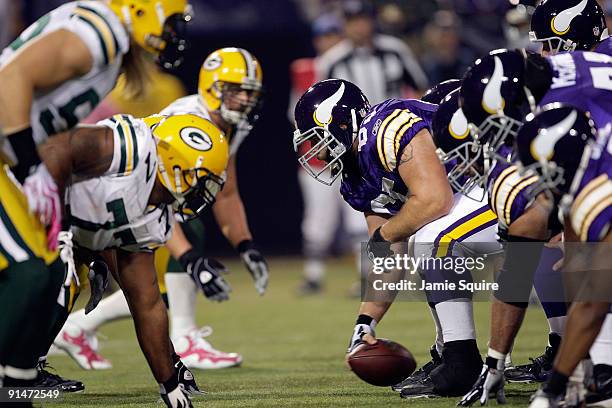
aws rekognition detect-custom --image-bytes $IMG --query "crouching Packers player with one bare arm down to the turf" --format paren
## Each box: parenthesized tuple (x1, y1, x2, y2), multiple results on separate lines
(43, 115, 229, 407)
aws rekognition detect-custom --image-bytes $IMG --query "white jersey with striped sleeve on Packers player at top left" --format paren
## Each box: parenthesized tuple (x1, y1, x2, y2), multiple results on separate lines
(0, 1, 130, 159)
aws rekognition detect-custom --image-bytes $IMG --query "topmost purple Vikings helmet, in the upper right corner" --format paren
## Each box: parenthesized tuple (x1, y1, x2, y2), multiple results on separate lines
(529, 0, 608, 54)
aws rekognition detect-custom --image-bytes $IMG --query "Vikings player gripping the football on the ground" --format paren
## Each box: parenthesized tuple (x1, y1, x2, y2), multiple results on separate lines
(294, 80, 504, 398)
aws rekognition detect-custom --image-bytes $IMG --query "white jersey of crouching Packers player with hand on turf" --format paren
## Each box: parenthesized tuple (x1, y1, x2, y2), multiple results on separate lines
(66, 115, 174, 252)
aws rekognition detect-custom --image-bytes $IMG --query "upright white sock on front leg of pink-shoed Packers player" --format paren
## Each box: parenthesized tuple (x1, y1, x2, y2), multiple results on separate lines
(164, 273, 198, 339)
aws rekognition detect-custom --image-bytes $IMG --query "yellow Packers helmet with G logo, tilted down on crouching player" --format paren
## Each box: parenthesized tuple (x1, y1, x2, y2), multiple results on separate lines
(151, 115, 229, 220)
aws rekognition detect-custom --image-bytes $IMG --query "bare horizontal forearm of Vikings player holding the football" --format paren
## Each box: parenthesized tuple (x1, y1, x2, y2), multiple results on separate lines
(380, 195, 452, 242)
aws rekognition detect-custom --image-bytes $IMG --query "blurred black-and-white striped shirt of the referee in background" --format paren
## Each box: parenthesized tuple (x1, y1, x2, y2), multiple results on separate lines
(317, 34, 427, 105)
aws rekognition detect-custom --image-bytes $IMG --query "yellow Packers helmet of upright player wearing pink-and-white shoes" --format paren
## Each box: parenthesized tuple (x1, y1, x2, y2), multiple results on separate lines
(198, 47, 263, 125)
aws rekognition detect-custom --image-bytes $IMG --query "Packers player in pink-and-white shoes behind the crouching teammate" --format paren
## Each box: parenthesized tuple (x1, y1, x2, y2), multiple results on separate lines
(55, 48, 268, 369)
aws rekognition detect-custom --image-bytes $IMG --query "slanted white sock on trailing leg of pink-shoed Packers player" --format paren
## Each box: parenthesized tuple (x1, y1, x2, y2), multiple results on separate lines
(68, 289, 131, 332)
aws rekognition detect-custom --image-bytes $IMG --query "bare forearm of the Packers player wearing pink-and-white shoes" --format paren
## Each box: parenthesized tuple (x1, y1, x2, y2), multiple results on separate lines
(213, 190, 252, 247)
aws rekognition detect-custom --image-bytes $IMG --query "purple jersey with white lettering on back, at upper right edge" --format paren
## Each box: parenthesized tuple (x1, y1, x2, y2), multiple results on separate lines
(539, 51, 612, 128)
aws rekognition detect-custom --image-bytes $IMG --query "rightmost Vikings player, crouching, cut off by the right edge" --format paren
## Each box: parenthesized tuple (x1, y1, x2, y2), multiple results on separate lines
(517, 107, 612, 407)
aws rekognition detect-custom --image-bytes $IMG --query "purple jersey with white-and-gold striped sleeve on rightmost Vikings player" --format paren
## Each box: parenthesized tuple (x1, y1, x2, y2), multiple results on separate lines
(562, 129, 612, 242)
